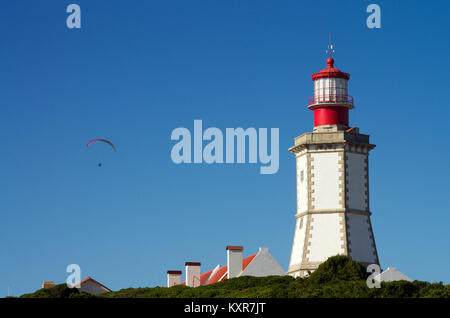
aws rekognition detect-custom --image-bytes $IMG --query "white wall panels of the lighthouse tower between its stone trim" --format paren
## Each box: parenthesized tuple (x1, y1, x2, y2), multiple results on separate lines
(289, 144, 377, 276)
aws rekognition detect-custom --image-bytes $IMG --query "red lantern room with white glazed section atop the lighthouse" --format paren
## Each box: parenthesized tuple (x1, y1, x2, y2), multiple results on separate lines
(308, 54, 354, 130)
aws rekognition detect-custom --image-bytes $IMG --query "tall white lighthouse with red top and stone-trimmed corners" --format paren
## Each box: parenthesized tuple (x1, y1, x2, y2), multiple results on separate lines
(288, 51, 379, 277)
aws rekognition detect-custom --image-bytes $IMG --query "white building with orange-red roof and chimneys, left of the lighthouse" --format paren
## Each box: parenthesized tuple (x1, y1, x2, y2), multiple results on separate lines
(167, 246, 286, 287)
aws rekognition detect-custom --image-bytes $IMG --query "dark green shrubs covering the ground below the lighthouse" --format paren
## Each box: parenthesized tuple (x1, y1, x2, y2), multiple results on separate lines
(15, 256, 450, 298)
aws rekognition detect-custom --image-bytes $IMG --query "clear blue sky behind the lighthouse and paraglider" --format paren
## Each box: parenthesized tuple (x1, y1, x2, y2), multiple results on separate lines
(0, 0, 450, 296)
